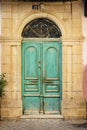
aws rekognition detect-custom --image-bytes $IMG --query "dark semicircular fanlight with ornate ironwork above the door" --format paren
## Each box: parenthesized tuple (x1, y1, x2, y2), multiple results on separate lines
(22, 18, 62, 38)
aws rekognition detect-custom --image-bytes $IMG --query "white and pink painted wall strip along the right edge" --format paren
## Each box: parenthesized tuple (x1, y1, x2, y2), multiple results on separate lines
(82, 4, 87, 101)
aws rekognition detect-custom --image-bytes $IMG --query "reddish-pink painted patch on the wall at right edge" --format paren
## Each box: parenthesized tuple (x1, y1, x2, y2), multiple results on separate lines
(83, 65, 87, 102)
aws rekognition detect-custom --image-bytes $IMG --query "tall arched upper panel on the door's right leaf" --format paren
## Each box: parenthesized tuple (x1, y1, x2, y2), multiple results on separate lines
(44, 45, 58, 78)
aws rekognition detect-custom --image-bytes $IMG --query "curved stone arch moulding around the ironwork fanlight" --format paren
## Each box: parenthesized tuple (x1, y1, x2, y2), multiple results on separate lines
(17, 13, 65, 38)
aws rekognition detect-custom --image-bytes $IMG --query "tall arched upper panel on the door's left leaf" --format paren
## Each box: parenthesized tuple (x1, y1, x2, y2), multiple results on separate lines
(24, 46, 38, 79)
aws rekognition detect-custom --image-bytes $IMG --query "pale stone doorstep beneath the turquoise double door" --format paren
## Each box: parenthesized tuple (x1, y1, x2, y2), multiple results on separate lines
(21, 114, 64, 120)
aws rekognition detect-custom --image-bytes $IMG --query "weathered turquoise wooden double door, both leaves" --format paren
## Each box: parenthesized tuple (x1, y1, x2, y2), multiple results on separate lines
(22, 41, 62, 114)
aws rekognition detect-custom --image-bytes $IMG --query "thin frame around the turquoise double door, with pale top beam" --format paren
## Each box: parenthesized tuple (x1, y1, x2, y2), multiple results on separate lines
(21, 38, 62, 114)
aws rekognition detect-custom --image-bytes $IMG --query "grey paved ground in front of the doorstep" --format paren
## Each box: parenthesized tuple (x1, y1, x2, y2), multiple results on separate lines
(0, 119, 87, 130)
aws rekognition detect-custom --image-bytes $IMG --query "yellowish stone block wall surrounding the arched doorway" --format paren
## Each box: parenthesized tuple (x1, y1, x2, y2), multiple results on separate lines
(0, 0, 86, 119)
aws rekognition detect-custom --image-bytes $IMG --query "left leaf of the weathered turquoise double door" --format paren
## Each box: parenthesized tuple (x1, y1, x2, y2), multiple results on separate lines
(22, 42, 40, 114)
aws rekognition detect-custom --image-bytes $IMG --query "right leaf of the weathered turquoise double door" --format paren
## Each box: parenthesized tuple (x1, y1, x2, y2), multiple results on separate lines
(43, 43, 60, 114)
